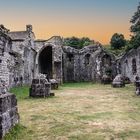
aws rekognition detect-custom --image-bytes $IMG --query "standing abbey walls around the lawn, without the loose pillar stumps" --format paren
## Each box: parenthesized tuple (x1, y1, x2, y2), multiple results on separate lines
(0, 25, 140, 87)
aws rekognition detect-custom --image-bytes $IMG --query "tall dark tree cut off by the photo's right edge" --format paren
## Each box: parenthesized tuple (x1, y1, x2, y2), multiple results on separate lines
(129, 3, 140, 48)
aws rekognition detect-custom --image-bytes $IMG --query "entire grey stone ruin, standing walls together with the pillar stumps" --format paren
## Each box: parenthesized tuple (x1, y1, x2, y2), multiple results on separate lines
(0, 21, 140, 137)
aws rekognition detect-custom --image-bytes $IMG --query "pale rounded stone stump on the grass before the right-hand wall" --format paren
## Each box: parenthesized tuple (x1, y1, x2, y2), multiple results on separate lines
(112, 74, 125, 87)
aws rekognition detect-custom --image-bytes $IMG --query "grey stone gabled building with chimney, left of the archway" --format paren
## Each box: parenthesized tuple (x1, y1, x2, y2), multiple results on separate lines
(8, 25, 36, 86)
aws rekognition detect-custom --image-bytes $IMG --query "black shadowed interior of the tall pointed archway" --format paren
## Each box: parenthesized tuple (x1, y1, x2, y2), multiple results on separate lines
(39, 46, 52, 79)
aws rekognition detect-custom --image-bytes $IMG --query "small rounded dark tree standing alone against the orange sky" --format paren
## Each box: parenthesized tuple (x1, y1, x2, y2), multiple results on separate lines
(110, 33, 126, 49)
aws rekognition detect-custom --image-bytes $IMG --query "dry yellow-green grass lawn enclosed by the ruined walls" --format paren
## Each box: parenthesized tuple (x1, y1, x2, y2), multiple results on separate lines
(5, 83, 140, 140)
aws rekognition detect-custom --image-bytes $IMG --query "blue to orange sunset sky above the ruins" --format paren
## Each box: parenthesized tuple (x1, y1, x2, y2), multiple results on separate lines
(0, 0, 140, 44)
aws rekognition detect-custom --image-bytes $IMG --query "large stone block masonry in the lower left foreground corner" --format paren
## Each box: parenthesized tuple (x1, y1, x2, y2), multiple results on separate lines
(0, 80, 19, 139)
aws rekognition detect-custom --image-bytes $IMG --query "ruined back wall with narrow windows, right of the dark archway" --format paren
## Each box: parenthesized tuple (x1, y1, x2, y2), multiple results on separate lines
(63, 44, 115, 82)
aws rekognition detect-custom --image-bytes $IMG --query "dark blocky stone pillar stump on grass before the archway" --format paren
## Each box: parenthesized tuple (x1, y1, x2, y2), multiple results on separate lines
(29, 74, 54, 98)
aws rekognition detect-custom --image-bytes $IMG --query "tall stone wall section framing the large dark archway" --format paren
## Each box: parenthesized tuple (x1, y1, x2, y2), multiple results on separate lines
(35, 36, 63, 83)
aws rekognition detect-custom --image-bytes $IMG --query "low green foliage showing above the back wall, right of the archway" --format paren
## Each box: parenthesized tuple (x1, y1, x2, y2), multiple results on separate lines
(64, 37, 94, 49)
